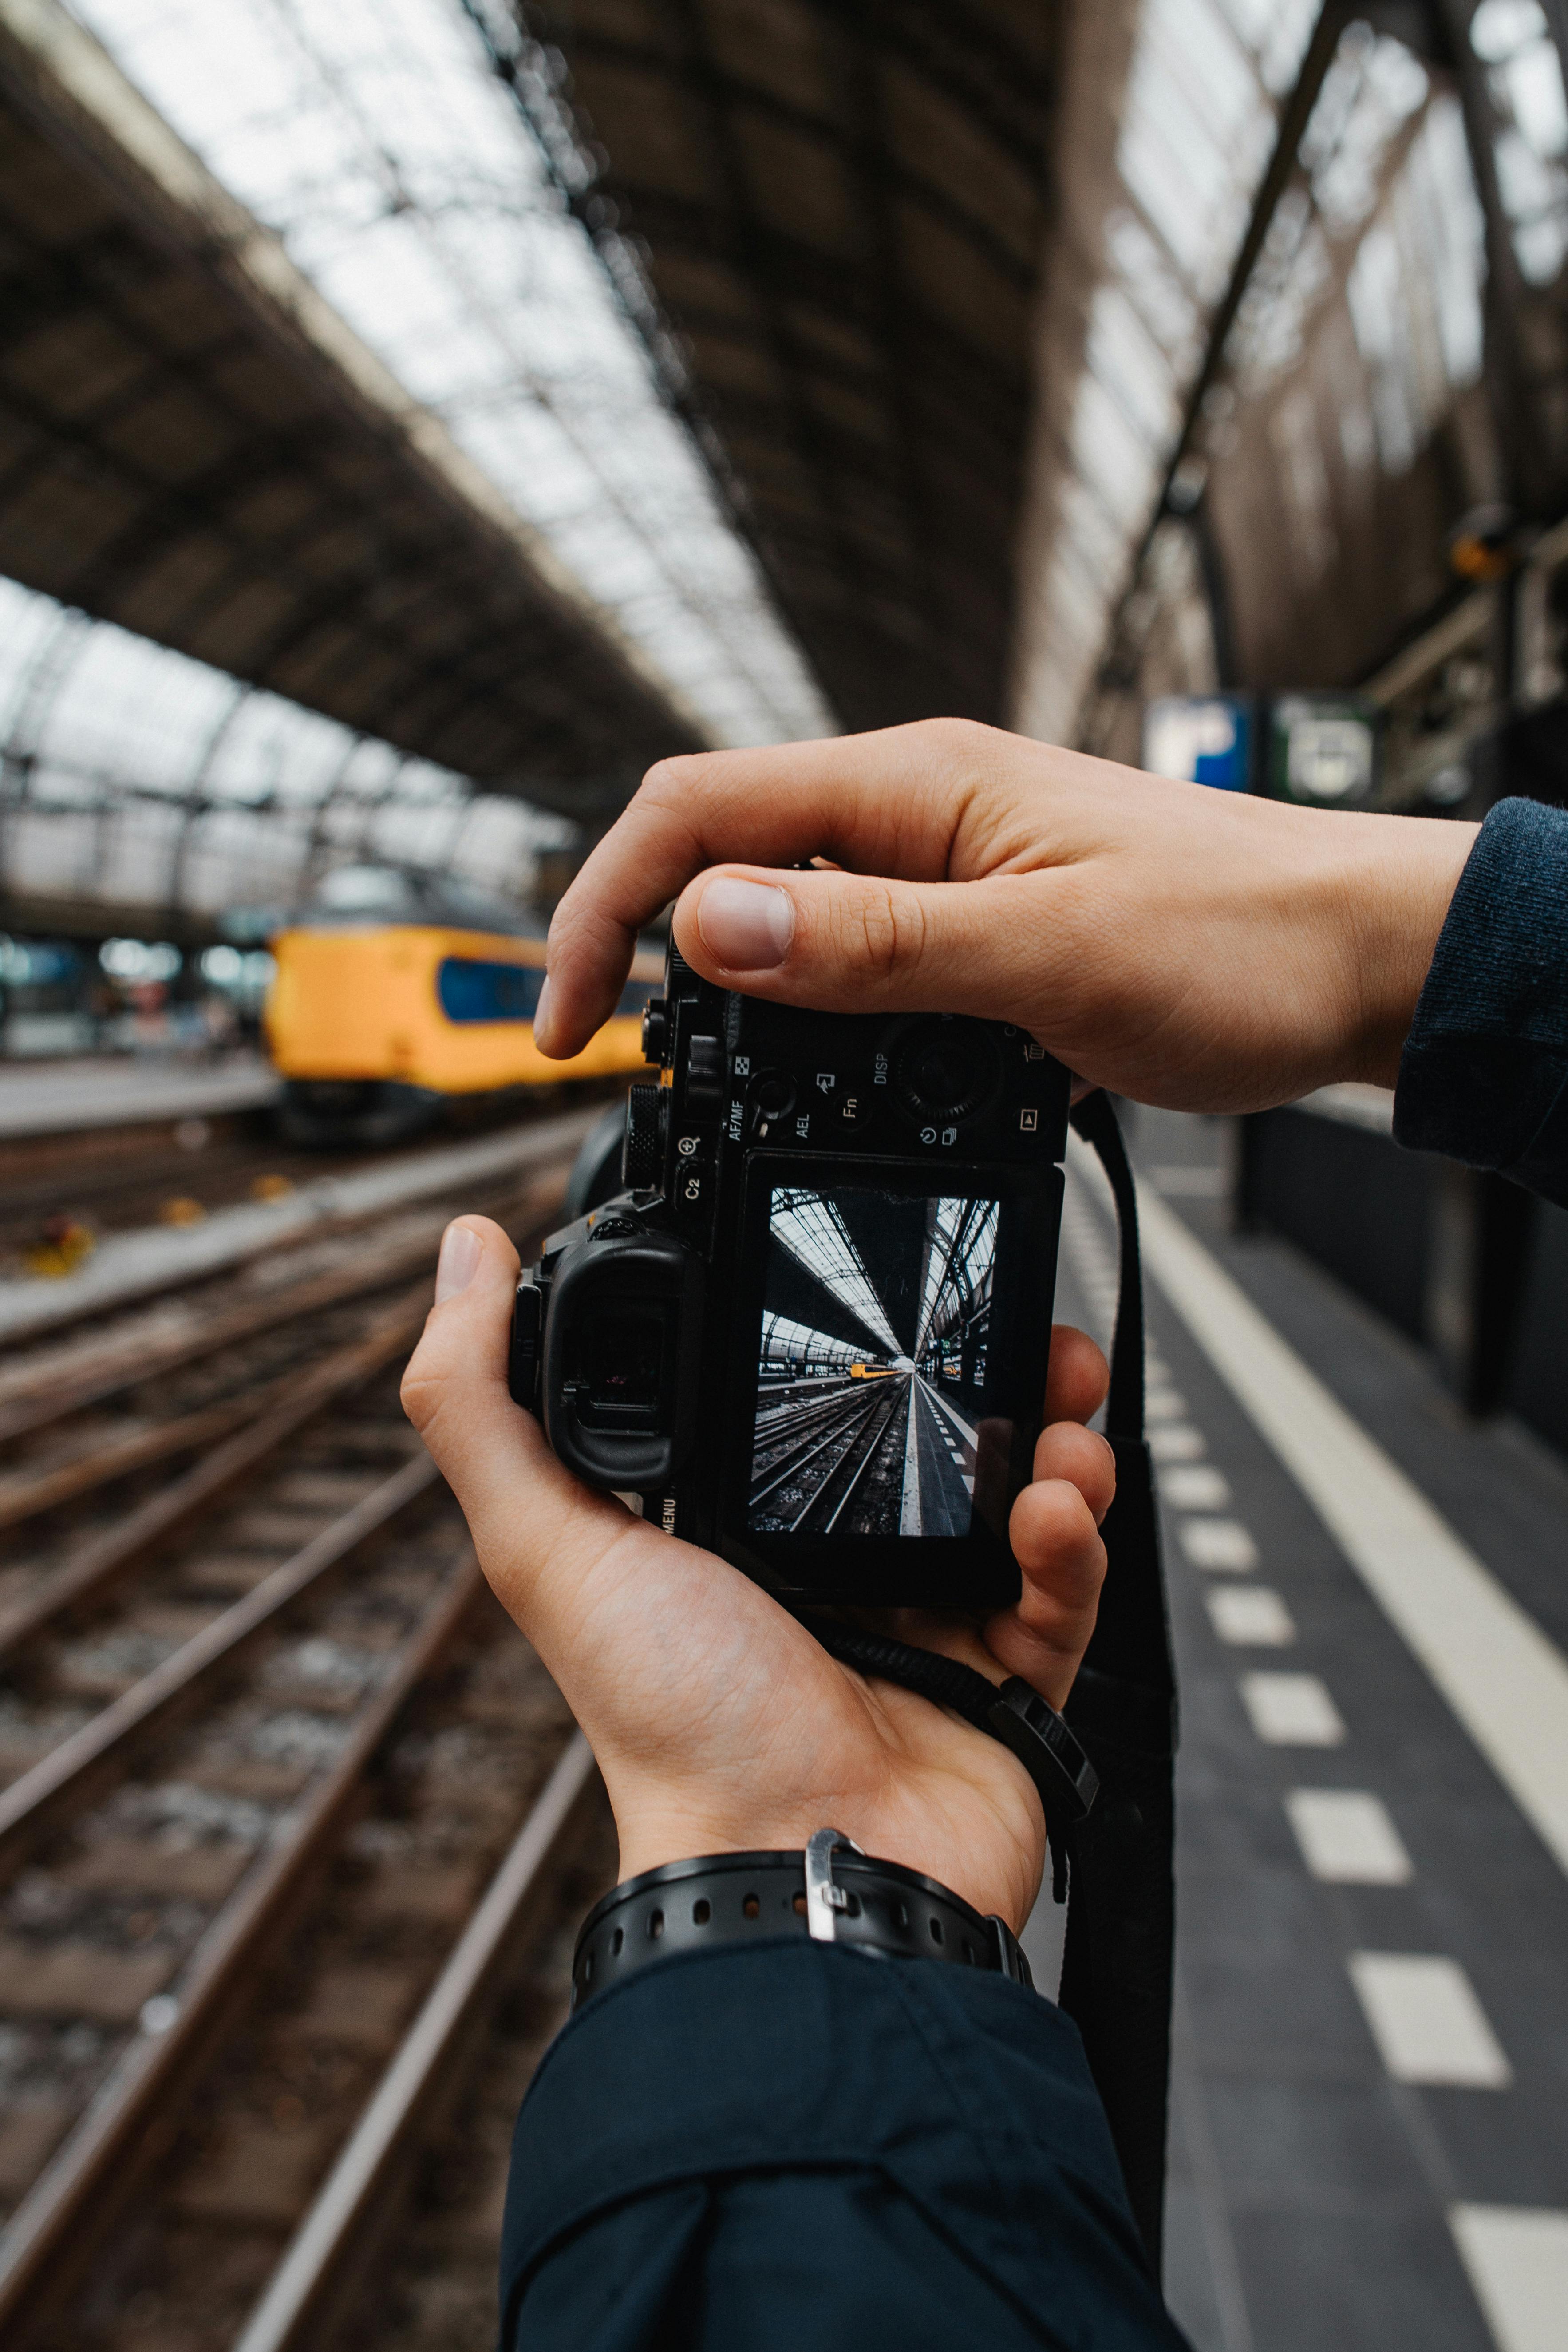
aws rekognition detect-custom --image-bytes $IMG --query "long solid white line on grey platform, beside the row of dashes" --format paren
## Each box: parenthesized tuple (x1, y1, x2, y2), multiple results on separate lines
(1138, 1186, 1568, 1872)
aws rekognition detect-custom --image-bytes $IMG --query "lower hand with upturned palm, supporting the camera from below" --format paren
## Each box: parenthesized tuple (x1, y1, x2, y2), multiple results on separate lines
(402, 1216, 1114, 1929)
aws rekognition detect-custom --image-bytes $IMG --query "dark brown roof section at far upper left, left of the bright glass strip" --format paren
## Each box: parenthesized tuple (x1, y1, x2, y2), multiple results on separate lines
(0, 0, 703, 804)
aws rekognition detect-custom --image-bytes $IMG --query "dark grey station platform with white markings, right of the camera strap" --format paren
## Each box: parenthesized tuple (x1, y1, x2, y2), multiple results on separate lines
(1032, 1112, 1568, 2352)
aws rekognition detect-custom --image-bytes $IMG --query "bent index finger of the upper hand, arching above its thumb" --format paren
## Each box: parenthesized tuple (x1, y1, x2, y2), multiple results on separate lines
(533, 719, 1039, 1059)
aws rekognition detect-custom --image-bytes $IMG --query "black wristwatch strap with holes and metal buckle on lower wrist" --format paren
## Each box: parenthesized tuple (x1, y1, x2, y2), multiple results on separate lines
(571, 1830, 1035, 2008)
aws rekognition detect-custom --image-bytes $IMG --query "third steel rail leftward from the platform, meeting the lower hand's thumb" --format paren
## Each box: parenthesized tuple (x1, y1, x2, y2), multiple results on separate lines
(0, 1456, 440, 1884)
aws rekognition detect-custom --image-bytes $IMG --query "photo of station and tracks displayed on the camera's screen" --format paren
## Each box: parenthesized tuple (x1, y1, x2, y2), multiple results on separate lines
(747, 1186, 999, 1536)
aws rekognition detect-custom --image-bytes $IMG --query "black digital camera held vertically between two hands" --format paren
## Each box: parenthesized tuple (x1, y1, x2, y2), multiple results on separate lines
(510, 948, 1070, 1611)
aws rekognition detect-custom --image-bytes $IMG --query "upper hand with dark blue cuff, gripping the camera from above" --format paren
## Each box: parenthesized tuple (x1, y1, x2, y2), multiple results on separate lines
(533, 719, 1476, 1110)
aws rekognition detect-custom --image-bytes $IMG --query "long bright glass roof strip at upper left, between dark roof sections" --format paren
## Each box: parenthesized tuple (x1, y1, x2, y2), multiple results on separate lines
(73, 0, 832, 743)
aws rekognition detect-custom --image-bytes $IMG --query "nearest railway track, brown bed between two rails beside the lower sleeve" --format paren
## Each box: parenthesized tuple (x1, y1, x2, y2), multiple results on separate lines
(0, 1538, 613, 2352)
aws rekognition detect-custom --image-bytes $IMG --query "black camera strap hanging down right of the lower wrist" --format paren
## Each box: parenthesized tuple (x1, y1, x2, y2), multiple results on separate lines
(802, 1094, 1175, 2279)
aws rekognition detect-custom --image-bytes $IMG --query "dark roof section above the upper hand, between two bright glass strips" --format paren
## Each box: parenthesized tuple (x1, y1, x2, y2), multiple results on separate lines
(524, 0, 1060, 729)
